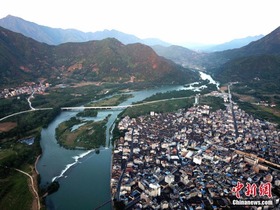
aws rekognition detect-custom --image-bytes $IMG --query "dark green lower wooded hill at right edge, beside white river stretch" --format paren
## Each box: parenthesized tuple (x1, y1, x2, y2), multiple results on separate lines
(215, 55, 280, 94)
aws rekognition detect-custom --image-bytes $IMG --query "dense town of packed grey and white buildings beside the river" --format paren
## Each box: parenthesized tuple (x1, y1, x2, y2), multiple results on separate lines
(111, 101, 280, 209)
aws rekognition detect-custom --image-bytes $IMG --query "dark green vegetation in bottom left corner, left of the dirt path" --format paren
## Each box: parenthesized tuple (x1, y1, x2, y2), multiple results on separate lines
(0, 136, 41, 210)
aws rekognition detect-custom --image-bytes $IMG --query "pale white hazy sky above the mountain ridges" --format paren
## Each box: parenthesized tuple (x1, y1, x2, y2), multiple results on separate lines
(0, 0, 280, 44)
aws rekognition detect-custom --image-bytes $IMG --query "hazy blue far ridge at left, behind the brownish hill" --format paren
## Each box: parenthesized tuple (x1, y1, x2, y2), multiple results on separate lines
(0, 15, 170, 46)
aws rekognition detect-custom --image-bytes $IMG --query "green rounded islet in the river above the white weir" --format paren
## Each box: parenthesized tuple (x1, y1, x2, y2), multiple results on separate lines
(56, 117, 108, 149)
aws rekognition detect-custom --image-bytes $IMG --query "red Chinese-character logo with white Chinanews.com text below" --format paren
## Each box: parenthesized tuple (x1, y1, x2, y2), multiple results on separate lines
(231, 181, 273, 206)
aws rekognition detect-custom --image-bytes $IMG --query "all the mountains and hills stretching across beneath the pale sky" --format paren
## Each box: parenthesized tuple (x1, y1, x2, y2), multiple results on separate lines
(0, 15, 280, 94)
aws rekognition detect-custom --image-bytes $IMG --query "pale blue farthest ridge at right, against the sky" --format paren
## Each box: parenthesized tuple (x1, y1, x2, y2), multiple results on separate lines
(200, 35, 264, 52)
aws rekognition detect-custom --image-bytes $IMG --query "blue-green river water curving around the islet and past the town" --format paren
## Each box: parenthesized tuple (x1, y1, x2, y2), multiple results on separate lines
(36, 73, 217, 210)
